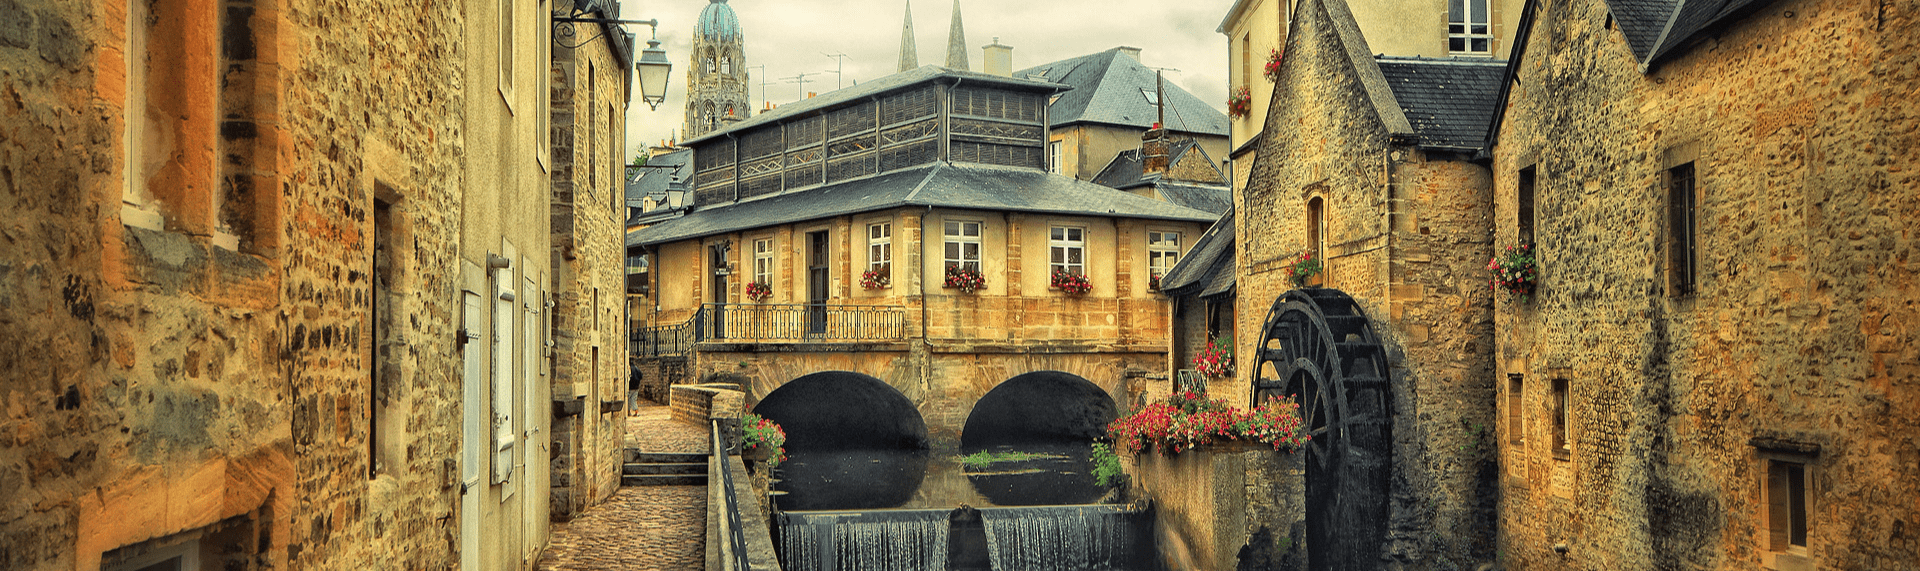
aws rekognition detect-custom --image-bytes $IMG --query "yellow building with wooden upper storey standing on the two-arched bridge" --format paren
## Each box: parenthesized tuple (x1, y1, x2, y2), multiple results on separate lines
(628, 65, 1213, 448)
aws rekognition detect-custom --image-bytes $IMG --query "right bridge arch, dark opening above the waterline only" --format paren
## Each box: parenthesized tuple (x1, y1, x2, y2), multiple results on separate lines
(960, 371, 1116, 452)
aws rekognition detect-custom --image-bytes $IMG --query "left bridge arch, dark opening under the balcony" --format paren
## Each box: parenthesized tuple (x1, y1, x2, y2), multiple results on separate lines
(753, 371, 927, 450)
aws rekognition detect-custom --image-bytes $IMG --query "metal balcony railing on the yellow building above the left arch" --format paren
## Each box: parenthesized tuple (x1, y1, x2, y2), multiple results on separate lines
(695, 304, 906, 342)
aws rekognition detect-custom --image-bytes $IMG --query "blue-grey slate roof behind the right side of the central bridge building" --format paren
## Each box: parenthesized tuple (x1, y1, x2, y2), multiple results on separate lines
(1014, 48, 1227, 137)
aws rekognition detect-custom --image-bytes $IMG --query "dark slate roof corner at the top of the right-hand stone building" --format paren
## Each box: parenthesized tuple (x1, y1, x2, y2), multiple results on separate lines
(1607, 0, 1772, 69)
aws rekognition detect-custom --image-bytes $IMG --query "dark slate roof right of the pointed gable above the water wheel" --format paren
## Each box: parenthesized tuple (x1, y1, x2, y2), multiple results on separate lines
(1377, 56, 1507, 150)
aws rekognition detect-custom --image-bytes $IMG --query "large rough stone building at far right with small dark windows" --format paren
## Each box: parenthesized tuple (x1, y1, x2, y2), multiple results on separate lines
(1492, 0, 1920, 569)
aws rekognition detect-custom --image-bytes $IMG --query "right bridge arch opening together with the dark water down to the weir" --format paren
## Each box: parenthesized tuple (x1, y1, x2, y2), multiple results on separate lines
(960, 371, 1116, 506)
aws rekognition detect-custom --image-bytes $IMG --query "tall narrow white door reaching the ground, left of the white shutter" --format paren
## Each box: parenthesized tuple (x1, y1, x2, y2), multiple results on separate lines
(461, 292, 490, 571)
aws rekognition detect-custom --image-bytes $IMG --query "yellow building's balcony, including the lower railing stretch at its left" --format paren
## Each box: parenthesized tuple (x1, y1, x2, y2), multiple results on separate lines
(628, 304, 906, 358)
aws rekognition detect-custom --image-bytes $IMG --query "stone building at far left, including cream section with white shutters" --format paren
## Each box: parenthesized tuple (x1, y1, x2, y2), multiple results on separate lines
(0, 0, 595, 569)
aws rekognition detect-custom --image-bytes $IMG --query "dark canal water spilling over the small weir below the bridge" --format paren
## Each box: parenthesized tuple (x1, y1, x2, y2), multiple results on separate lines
(774, 440, 1158, 571)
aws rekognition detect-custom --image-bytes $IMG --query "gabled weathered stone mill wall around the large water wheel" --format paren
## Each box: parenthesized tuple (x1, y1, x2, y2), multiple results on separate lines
(1213, 2, 1498, 569)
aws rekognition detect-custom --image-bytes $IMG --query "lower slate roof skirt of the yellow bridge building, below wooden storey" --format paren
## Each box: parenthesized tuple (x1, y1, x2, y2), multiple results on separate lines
(626, 163, 1213, 246)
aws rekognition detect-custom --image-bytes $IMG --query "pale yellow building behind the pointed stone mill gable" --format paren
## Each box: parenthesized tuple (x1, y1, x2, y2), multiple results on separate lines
(1213, 0, 1526, 192)
